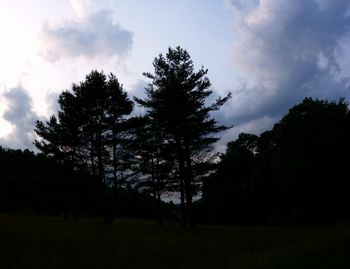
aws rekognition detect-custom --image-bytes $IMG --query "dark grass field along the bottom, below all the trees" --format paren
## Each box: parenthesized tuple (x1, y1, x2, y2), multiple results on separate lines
(0, 215, 350, 269)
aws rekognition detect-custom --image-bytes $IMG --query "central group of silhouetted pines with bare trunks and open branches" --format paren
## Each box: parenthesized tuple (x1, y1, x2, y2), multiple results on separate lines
(31, 47, 230, 224)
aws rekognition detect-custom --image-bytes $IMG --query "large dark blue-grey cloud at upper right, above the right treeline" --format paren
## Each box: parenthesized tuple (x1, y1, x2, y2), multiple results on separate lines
(220, 0, 350, 136)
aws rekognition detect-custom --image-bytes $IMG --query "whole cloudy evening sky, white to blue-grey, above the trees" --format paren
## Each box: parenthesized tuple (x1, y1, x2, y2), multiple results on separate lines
(0, 0, 350, 149)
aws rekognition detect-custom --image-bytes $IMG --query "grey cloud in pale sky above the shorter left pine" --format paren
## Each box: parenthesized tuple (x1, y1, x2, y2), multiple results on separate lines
(40, 8, 133, 61)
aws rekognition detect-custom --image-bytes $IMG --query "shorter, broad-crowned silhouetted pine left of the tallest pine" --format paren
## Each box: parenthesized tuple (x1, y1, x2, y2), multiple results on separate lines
(35, 71, 133, 222)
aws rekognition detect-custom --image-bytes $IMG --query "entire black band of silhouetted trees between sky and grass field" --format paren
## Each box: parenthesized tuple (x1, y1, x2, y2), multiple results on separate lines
(0, 47, 350, 226)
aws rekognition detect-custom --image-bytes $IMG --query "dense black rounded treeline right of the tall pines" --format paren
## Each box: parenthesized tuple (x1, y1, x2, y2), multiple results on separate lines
(199, 98, 350, 224)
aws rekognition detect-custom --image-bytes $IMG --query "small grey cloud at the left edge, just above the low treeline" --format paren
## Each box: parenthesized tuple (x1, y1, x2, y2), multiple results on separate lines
(0, 86, 39, 149)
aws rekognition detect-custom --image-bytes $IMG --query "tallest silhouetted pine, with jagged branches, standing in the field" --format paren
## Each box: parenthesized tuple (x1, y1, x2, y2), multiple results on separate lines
(136, 47, 230, 224)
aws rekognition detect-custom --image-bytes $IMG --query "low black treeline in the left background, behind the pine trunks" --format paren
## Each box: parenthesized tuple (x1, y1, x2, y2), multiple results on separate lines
(0, 147, 178, 221)
